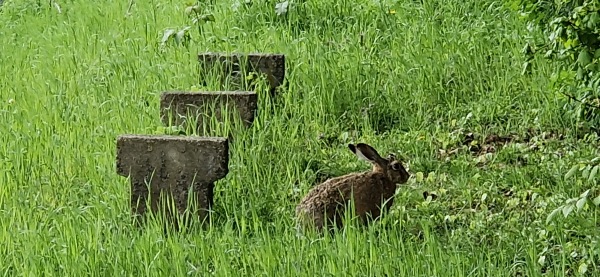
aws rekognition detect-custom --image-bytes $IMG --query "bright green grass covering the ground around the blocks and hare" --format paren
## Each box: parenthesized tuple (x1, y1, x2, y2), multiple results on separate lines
(0, 0, 600, 276)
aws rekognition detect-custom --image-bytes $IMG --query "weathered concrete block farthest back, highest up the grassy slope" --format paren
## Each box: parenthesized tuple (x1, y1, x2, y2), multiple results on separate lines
(198, 53, 285, 95)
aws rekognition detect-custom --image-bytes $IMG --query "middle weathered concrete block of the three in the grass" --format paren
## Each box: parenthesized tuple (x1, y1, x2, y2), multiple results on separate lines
(160, 91, 258, 133)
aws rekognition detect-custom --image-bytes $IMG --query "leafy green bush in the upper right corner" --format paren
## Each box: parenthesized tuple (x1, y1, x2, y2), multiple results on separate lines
(511, 0, 600, 128)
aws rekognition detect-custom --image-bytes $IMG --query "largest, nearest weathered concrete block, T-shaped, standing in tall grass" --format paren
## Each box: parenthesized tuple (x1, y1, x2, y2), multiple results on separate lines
(117, 135, 229, 226)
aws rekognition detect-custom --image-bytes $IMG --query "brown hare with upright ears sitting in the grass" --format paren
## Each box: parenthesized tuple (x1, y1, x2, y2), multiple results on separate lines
(296, 143, 410, 231)
